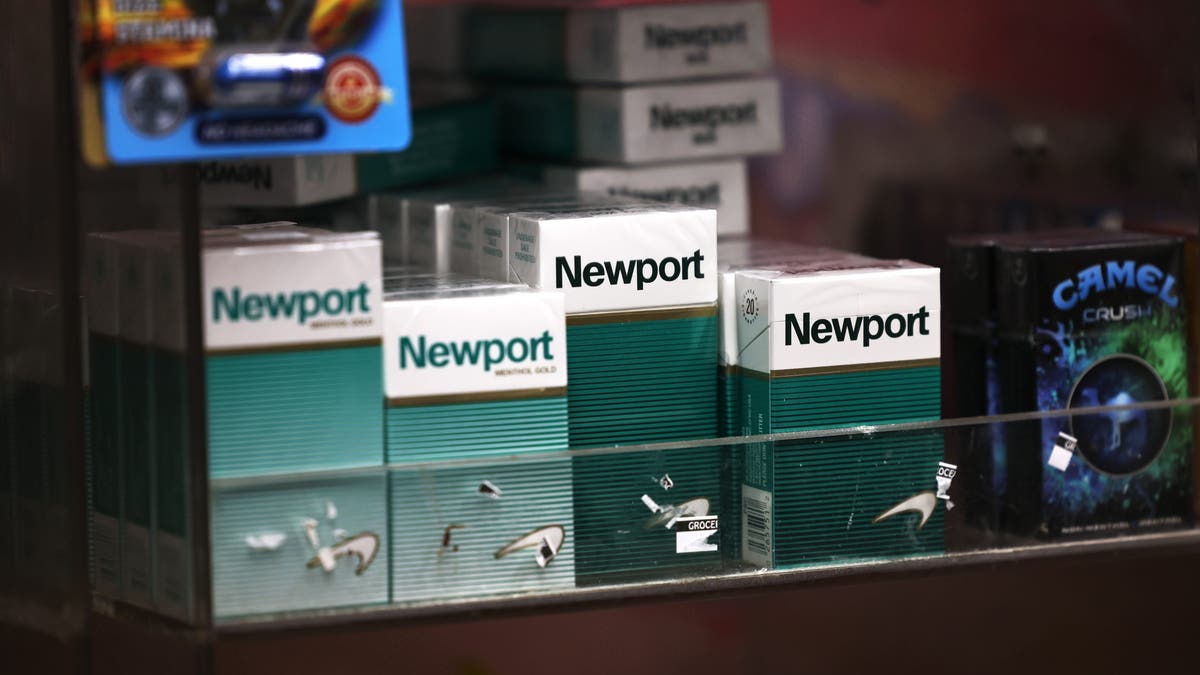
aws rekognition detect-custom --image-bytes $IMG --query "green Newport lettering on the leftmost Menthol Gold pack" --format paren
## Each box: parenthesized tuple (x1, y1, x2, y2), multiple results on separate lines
(212, 281, 371, 325)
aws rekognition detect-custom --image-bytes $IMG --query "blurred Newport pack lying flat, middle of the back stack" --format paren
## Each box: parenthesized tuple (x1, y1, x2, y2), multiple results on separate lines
(496, 77, 784, 165)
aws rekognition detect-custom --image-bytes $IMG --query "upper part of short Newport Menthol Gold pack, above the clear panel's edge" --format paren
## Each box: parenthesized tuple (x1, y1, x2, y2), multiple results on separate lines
(383, 275, 568, 464)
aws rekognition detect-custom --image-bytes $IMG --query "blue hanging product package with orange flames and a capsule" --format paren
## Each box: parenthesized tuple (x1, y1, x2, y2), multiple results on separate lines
(79, 0, 412, 166)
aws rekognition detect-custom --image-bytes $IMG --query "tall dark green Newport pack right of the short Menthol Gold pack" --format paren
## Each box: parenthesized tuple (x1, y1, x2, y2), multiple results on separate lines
(509, 202, 721, 584)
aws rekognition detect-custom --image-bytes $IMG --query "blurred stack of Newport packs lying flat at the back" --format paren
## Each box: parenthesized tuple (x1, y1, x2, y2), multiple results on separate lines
(406, 1, 782, 239)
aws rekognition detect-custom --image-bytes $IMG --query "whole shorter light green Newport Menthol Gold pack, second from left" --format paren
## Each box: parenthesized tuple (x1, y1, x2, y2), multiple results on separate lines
(384, 275, 575, 603)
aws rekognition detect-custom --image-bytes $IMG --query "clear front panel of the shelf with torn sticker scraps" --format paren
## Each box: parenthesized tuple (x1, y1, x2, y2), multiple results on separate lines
(211, 398, 1200, 632)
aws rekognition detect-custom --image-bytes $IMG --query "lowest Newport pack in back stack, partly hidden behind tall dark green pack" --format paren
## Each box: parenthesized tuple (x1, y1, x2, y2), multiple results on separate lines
(542, 160, 750, 237)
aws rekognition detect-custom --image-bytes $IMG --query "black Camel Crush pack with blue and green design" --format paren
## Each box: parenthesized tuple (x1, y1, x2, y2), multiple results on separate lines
(995, 231, 1194, 539)
